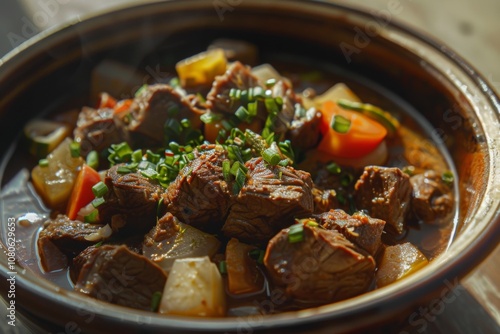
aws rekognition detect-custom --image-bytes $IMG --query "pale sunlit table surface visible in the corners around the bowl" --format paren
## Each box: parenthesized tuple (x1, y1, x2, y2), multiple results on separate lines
(0, 0, 500, 334)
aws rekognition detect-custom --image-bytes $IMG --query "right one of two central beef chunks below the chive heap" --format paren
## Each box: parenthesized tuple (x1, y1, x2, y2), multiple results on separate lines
(222, 158, 314, 243)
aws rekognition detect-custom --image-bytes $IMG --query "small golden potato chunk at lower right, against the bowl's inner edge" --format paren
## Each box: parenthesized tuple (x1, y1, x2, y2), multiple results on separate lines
(376, 242, 429, 287)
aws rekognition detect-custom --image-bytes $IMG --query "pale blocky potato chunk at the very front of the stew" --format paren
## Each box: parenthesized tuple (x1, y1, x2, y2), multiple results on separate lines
(160, 256, 226, 317)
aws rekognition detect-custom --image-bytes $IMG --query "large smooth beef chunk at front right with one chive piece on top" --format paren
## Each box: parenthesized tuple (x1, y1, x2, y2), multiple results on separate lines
(264, 223, 375, 304)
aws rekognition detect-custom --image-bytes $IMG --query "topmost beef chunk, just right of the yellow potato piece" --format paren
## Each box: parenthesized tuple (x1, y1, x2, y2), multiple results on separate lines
(207, 61, 266, 119)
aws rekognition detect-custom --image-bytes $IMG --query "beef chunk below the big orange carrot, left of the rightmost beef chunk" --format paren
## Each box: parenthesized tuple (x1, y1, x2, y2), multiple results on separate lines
(354, 166, 411, 234)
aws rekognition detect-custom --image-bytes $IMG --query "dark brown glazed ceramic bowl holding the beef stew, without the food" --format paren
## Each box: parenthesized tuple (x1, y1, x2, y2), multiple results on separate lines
(0, 0, 500, 333)
